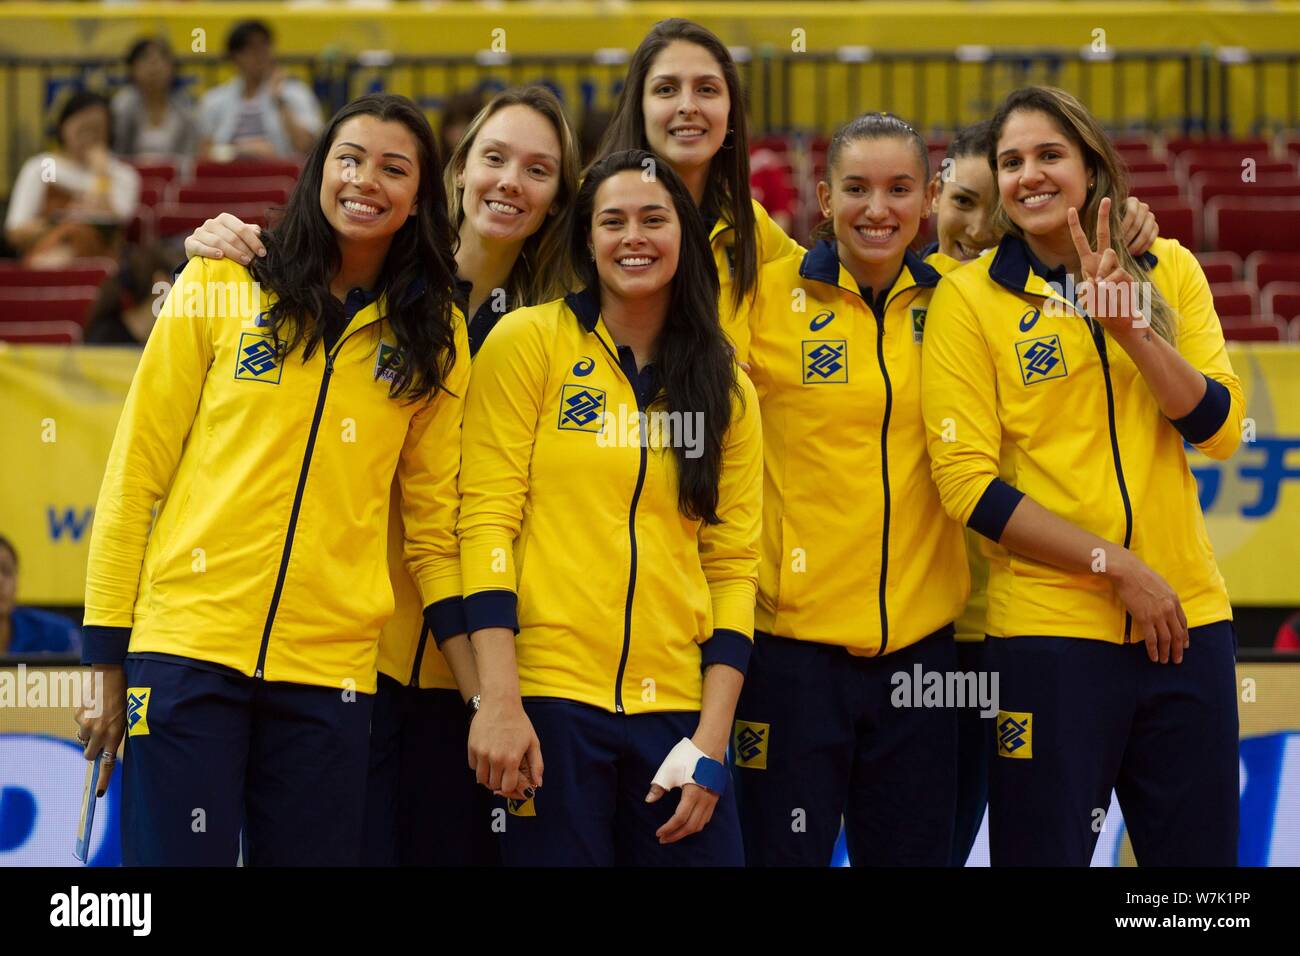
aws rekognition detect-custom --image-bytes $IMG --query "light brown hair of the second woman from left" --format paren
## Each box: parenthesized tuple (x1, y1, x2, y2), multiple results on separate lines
(443, 86, 579, 306)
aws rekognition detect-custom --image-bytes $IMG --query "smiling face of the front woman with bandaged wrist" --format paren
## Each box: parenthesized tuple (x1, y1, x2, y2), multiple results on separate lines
(590, 169, 681, 299)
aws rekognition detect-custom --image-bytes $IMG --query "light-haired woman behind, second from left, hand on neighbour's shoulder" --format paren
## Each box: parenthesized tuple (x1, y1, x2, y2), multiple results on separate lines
(175, 86, 579, 866)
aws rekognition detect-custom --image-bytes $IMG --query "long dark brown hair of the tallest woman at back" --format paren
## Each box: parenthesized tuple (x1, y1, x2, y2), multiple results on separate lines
(601, 18, 758, 308)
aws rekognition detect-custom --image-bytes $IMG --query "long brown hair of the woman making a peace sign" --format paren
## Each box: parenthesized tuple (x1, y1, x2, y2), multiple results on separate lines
(988, 86, 1178, 343)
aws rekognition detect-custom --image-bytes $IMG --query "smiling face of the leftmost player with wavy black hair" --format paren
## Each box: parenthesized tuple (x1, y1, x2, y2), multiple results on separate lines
(320, 114, 420, 243)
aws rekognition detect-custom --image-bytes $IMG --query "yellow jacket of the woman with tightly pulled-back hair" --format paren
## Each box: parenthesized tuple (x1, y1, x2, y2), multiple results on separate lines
(748, 239, 967, 654)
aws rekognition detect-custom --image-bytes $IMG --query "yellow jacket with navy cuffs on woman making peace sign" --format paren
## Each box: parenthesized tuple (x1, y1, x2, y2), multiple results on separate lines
(923, 237, 1243, 644)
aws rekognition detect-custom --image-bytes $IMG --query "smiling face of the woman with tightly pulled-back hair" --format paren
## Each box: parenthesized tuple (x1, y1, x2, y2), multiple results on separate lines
(816, 137, 933, 281)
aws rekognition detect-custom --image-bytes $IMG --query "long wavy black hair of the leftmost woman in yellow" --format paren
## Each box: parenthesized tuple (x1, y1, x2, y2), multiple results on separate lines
(250, 94, 456, 399)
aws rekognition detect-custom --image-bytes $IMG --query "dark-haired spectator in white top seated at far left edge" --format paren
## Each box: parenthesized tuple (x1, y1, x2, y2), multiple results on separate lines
(5, 90, 140, 268)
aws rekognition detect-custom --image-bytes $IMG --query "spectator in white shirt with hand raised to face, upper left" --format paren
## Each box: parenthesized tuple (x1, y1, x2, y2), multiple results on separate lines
(199, 20, 324, 160)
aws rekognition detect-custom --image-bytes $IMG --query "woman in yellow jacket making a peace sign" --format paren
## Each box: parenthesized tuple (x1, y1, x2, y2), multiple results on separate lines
(922, 87, 1243, 866)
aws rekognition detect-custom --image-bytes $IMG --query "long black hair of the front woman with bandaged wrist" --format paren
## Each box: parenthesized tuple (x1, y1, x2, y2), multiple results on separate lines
(571, 150, 742, 524)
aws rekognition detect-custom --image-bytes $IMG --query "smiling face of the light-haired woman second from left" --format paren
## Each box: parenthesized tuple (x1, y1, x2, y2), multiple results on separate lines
(456, 104, 560, 242)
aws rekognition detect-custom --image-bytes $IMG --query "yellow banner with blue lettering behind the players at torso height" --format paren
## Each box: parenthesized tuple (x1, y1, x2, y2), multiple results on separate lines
(0, 345, 1300, 606)
